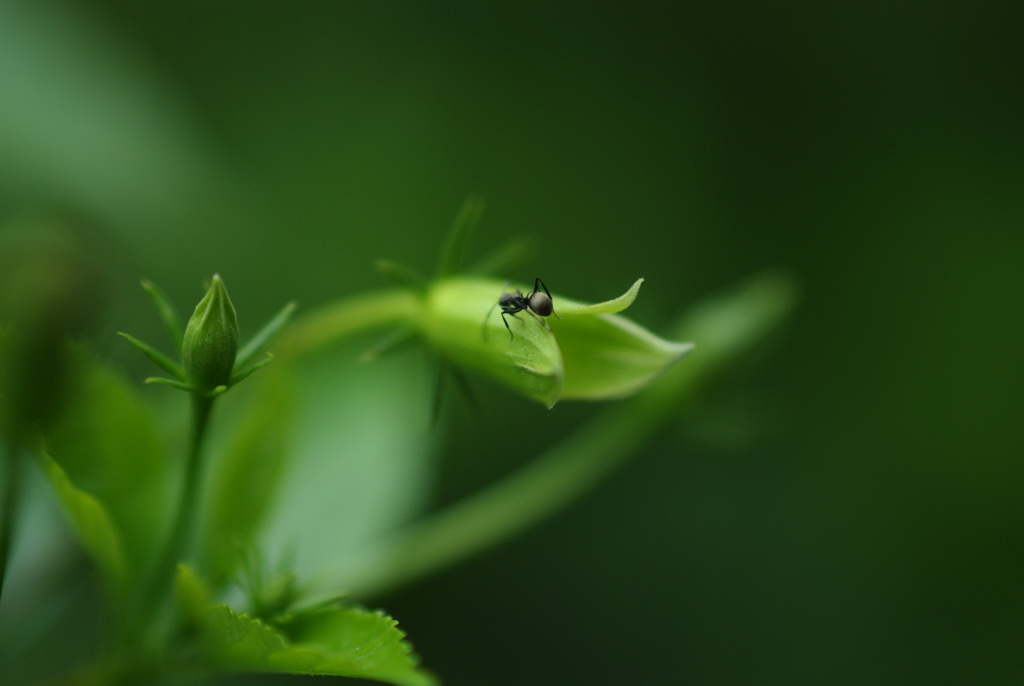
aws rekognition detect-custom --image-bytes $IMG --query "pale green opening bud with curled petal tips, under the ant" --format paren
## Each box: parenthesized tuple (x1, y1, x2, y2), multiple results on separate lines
(421, 278, 693, 408)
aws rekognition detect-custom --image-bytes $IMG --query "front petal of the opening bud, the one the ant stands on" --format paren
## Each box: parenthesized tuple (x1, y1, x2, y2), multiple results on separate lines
(421, 278, 563, 408)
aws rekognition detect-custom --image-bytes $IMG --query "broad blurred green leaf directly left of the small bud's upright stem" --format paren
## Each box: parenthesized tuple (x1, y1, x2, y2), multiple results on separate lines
(46, 350, 170, 566)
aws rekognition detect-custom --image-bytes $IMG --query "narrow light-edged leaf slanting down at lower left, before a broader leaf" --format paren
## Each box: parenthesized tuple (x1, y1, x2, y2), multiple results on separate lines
(38, 453, 129, 588)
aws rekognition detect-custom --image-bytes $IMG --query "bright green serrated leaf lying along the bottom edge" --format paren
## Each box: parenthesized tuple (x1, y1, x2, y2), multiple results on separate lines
(202, 604, 437, 686)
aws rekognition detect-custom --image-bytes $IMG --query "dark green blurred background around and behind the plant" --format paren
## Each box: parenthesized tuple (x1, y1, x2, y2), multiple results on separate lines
(0, 0, 1024, 686)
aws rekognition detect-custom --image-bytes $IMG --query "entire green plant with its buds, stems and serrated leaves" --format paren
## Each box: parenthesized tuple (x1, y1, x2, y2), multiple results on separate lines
(0, 202, 792, 685)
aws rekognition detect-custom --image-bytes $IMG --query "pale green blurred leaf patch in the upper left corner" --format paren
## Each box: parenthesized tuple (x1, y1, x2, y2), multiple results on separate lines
(0, 2, 218, 231)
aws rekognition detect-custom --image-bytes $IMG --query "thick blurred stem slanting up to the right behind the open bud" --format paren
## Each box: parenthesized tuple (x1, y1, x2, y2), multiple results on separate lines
(315, 273, 796, 599)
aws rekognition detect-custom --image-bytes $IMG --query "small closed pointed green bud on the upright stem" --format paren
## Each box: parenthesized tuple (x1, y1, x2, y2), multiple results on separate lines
(181, 274, 239, 393)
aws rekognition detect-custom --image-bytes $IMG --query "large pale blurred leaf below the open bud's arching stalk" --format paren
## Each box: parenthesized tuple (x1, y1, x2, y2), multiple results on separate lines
(252, 340, 437, 578)
